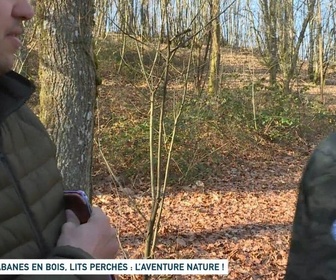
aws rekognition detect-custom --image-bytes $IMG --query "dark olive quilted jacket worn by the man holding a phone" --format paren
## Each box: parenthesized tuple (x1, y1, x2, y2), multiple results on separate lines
(0, 72, 107, 280)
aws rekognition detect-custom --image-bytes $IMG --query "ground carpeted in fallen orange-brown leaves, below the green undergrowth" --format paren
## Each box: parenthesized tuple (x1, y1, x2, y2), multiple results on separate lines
(89, 42, 334, 280)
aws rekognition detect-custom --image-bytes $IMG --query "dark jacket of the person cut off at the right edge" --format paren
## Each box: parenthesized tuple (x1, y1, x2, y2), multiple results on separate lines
(285, 133, 336, 280)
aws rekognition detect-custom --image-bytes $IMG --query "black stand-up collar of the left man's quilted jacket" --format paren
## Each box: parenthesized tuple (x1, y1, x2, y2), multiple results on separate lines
(0, 71, 35, 122)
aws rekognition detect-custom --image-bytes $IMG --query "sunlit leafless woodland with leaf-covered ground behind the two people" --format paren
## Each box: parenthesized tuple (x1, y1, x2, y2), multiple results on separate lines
(16, 0, 336, 279)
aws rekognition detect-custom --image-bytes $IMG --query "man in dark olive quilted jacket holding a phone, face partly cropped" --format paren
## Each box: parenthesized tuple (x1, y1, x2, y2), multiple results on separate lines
(0, 0, 118, 280)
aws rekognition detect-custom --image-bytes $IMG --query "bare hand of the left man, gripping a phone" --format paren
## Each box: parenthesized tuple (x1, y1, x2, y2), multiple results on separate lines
(57, 207, 119, 259)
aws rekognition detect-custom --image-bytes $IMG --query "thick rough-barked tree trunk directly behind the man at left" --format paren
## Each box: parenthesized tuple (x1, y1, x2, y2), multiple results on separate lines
(37, 0, 96, 197)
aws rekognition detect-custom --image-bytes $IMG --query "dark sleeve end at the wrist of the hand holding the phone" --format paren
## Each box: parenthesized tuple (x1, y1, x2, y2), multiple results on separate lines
(15, 246, 114, 280)
